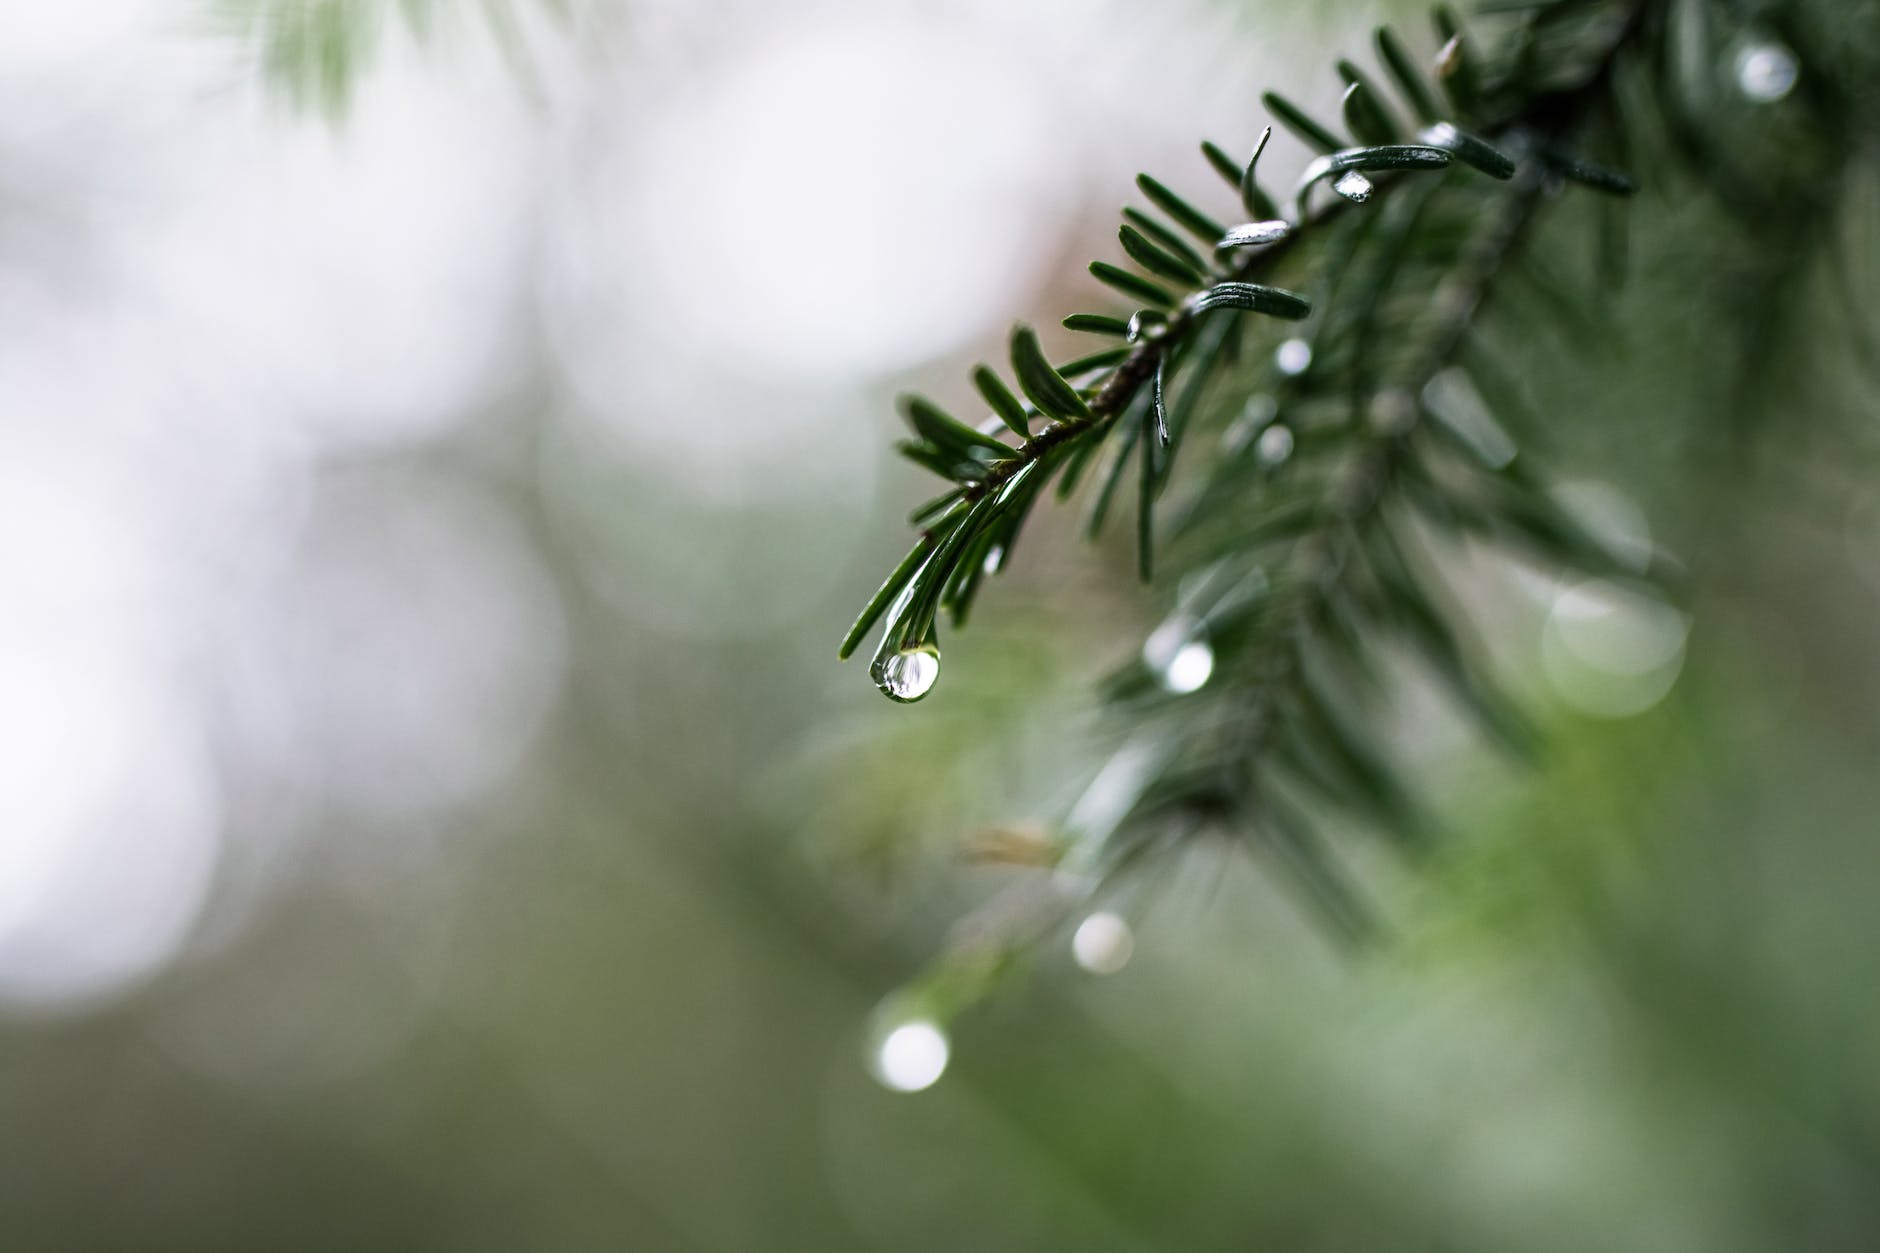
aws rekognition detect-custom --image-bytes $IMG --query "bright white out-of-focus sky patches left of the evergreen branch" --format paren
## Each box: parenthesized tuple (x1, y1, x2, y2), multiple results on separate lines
(0, 0, 1338, 1012)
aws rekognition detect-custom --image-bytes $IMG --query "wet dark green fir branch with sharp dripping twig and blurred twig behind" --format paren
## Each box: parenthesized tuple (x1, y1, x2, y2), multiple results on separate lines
(842, 0, 1660, 933)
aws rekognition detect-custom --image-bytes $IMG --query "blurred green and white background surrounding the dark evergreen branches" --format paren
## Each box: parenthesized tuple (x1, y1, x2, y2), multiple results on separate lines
(0, 0, 1880, 1251)
